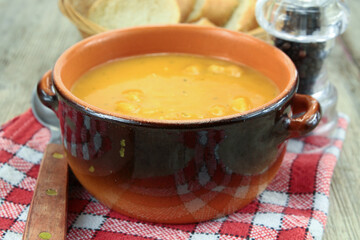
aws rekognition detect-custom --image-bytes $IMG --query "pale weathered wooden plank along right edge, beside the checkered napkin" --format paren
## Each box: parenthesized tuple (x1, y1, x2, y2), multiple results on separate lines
(324, 38, 360, 240)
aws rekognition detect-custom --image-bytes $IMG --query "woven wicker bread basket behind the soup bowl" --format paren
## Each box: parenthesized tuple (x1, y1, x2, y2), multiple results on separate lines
(59, 0, 269, 42)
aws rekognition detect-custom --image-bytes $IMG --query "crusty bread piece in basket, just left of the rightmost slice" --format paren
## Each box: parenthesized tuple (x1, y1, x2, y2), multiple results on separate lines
(187, 0, 238, 26)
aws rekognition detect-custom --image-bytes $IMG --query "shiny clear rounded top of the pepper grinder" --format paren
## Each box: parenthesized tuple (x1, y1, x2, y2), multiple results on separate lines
(255, 0, 350, 42)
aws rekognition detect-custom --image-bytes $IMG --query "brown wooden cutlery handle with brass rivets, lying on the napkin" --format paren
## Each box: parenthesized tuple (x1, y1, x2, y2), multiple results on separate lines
(23, 144, 68, 240)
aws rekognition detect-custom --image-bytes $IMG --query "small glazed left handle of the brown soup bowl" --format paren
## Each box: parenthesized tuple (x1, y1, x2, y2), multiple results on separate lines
(37, 70, 58, 111)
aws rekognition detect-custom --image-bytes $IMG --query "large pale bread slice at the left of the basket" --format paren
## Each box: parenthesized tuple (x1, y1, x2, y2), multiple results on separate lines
(88, 0, 180, 29)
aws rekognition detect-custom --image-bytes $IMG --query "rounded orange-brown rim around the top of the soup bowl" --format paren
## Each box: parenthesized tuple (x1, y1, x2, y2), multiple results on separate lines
(52, 24, 299, 128)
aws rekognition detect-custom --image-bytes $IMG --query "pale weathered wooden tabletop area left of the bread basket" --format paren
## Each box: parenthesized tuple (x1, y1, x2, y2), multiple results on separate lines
(0, 0, 81, 123)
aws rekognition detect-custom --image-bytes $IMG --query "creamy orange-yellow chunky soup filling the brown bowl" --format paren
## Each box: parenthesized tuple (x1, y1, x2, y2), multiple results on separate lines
(71, 54, 279, 120)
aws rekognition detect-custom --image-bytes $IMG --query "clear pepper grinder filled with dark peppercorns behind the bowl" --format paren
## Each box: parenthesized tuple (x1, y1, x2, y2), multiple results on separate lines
(255, 0, 350, 135)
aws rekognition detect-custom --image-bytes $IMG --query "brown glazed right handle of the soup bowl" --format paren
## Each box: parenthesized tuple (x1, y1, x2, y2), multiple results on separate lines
(285, 93, 321, 138)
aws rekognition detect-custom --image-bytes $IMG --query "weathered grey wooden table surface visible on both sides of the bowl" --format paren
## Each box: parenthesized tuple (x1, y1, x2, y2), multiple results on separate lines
(0, 0, 360, 240)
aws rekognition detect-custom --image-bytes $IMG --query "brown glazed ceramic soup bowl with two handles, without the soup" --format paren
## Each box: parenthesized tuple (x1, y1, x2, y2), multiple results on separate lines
(38, 25, 321, 223)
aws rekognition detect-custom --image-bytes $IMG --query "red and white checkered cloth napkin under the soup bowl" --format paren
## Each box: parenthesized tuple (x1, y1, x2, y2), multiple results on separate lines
(0, 110, 348, 240)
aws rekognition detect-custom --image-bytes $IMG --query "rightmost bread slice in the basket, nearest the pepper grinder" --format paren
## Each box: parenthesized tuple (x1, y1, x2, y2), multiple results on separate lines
(224, 0, 259, 32)
